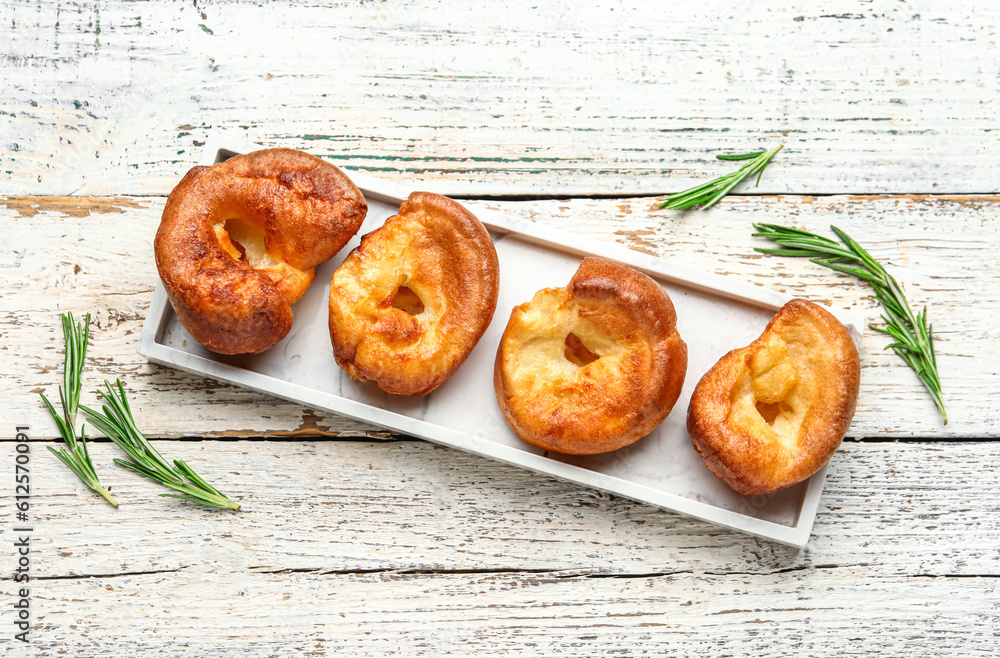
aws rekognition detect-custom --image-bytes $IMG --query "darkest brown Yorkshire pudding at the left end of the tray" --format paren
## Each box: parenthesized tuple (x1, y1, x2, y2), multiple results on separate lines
(154, 149, 368, 354)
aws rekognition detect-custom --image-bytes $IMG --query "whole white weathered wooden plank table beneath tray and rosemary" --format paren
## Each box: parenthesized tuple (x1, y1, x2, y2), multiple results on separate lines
(0, 0, 1000, 656)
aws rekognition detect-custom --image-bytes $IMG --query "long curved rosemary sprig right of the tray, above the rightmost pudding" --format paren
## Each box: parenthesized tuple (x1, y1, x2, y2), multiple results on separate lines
(753, 223, 948, 425)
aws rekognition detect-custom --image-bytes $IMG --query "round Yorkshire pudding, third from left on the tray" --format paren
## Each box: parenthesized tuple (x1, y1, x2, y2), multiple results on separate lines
(493, 258, 687, 455)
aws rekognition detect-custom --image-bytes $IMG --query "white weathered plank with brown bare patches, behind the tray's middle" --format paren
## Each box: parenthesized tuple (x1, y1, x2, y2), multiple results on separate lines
(0, 196, 1000, 439)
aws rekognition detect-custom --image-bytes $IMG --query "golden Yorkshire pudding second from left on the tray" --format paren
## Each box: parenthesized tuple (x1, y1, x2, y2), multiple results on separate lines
(330, 192, 500, 395)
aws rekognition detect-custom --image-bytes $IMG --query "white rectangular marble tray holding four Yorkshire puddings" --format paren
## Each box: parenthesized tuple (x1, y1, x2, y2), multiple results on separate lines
(139, 134, 864, 548)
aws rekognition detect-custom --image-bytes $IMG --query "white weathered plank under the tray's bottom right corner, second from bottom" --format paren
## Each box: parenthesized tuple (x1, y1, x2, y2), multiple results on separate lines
(11, 439, 1000, 578)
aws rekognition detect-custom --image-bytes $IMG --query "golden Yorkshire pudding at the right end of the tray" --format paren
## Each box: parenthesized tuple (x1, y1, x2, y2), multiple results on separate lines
(687, 299, 861, 494)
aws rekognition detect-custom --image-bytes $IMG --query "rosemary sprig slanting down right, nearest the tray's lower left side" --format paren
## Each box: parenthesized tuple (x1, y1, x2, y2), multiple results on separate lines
(80, 380, 240, 510)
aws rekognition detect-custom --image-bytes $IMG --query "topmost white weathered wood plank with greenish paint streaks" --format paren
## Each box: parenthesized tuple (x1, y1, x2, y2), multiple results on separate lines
(0, 0, 1000, 195)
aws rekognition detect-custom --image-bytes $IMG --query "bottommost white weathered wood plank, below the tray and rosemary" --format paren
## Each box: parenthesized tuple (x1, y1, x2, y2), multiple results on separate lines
(6, 569, 998, 658)
